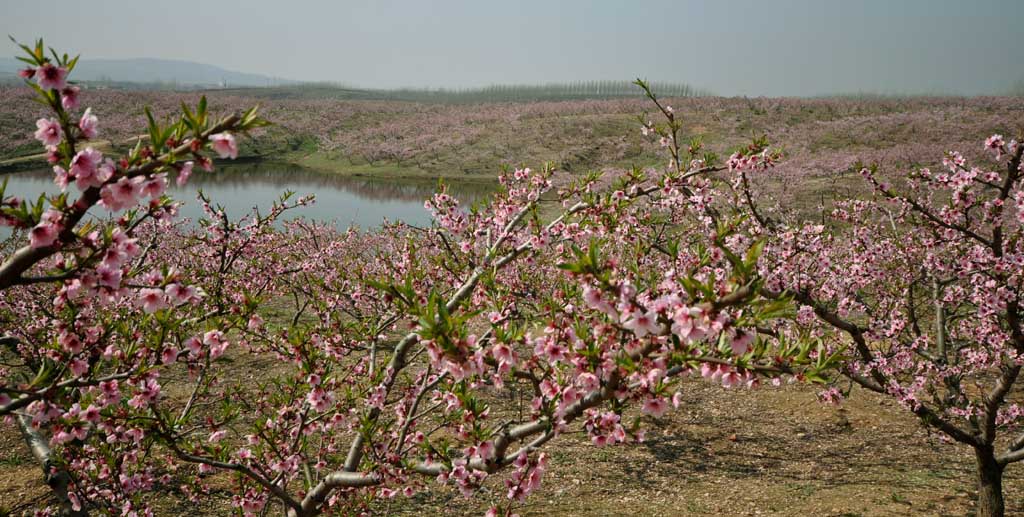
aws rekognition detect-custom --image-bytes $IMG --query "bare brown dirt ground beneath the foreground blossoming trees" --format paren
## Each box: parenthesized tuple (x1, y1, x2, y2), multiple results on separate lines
(0, 379, 1024, 517)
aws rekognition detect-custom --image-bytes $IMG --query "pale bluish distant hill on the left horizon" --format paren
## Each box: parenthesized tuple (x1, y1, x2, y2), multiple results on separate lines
(0, 57, 297, 88)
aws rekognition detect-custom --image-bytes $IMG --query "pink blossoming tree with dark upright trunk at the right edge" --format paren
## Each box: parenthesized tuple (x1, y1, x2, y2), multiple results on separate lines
(741, 126, 1024, 517)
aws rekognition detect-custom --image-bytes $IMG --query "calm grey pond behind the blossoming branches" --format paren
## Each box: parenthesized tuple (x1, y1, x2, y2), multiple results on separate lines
(0, 163, 497, 229)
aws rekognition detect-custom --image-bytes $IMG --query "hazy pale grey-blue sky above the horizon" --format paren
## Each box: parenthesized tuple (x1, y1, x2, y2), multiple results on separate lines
(0, 0, 1024, 95)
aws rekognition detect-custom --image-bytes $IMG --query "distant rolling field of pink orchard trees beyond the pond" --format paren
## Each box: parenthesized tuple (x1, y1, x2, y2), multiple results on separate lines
(0, 87, 1024, 198)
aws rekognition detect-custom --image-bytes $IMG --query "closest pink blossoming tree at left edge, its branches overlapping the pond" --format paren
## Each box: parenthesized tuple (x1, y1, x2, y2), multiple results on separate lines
(0, 42, 284, 513)
